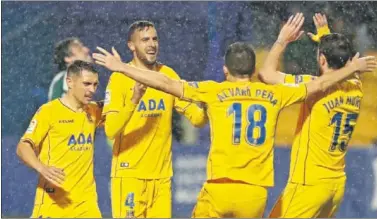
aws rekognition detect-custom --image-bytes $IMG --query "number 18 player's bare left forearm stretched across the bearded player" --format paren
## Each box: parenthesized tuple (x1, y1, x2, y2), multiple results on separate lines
(119, 63, 183, 97)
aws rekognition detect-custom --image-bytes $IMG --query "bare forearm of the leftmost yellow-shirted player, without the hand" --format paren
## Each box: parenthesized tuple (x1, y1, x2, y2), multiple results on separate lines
(16, 141, 43, 172)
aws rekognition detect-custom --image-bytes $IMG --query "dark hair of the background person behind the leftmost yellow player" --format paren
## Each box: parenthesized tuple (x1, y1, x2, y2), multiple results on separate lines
(54, 37, 80, 71)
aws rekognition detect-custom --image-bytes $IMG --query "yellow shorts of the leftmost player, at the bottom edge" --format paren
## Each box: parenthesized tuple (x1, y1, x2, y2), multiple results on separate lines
(31, 201, 102, 218)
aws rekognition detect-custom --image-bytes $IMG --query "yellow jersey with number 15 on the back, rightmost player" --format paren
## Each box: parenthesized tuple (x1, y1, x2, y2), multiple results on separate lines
(285, 75, 363, 185)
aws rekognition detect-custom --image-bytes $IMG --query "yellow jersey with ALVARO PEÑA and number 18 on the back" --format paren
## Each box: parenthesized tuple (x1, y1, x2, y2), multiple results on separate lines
(182, 81, 307, 187)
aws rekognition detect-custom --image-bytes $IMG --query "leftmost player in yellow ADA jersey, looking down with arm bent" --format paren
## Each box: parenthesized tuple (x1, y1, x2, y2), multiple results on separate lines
(17, 61, 102, 218)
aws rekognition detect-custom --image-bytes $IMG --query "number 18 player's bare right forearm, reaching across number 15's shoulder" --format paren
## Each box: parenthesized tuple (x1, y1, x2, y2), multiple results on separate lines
(306, 65, 357, 96)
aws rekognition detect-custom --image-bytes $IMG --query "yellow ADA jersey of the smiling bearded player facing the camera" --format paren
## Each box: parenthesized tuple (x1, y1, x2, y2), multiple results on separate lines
(103, 65, 207, 179)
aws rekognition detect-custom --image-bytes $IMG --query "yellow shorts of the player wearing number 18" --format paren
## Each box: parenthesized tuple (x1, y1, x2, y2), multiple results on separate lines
(192, 182, 267, 218)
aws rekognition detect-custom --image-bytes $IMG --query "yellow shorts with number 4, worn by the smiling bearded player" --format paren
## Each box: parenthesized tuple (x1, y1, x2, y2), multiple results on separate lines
(111, 177, 171, 218)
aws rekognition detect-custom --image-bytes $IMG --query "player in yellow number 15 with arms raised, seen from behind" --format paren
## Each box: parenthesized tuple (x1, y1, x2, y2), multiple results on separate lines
(260, 14, 374, 218)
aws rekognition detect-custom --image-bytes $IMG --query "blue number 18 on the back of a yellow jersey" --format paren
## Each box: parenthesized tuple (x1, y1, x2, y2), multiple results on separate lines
(227, 103, 267, 146)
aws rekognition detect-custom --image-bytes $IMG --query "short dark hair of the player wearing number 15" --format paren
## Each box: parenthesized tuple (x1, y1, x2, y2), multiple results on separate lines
(319, 33, 356, 69)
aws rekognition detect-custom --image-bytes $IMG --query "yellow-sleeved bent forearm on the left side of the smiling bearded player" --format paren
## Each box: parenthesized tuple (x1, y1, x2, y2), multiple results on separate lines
(105, 103, 136, 139)
